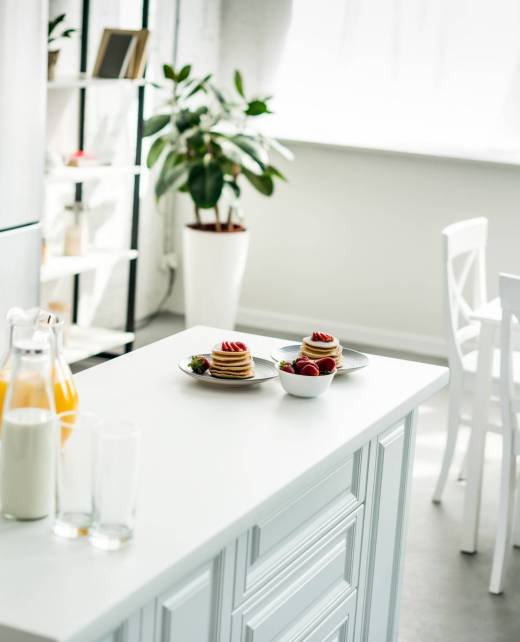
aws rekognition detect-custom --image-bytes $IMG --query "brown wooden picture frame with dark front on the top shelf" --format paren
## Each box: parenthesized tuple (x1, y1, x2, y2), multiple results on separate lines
(92, 27, 150, 79)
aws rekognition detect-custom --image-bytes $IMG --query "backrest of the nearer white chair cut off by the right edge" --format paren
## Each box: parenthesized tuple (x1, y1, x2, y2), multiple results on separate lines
(500, 274, 520, 452)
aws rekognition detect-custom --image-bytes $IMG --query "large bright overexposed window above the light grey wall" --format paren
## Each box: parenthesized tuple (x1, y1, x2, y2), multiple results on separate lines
(262, 0, 520, 151)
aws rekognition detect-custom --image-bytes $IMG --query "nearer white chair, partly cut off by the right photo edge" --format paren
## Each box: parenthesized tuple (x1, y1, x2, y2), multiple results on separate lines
(489, 274, 520, 593)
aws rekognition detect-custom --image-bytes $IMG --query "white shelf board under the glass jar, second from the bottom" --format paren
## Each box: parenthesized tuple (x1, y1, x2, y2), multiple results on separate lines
(40, 249, 138, 283)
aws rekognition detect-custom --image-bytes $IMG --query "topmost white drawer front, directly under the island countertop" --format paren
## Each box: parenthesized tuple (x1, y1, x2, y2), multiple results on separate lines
(234, 448, 367, 606)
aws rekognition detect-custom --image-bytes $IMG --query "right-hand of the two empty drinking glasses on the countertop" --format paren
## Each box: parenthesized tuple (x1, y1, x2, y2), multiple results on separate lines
(90, 420, 141, 550)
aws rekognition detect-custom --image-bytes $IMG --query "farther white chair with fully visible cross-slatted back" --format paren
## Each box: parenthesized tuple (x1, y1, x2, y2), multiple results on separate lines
(433, 218, 490, 503)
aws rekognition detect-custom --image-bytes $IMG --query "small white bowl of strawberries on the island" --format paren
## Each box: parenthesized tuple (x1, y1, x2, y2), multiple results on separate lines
(277, 356, 336, 397)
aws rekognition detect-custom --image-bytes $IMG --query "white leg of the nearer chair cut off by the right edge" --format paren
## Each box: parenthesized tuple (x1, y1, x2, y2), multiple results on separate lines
(489, 440, 516, 594)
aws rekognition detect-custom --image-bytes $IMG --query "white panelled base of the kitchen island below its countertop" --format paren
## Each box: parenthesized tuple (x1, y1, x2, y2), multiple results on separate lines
(99, 412, 415, 642)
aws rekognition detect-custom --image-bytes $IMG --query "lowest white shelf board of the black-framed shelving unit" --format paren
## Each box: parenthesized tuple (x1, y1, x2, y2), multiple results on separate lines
(64, 325, 135, 363)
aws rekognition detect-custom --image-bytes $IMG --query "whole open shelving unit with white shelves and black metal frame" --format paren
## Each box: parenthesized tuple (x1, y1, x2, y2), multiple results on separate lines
(44, 5, 149, 363)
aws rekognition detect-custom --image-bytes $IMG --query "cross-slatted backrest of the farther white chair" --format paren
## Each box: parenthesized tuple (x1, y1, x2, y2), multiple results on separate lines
(442, 217, 488, 368)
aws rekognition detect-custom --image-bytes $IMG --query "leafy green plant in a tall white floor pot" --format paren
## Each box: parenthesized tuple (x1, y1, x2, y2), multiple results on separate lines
(143, 65, 292, 328)
